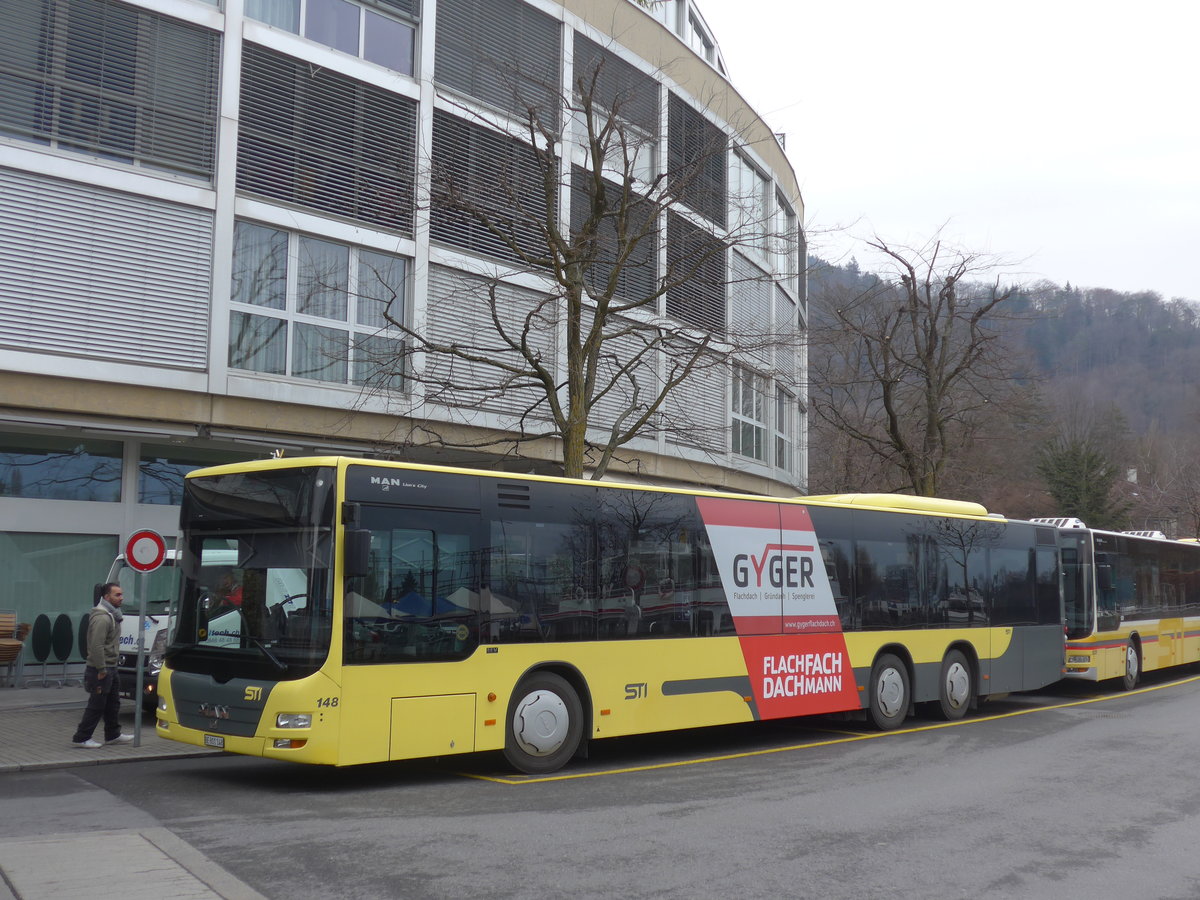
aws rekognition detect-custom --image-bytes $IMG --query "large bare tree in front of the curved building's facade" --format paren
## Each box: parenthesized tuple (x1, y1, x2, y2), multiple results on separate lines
(343, 42, 802, 478)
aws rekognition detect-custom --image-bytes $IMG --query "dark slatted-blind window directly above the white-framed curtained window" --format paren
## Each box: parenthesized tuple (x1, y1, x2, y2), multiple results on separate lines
(238, 43, 416, 234)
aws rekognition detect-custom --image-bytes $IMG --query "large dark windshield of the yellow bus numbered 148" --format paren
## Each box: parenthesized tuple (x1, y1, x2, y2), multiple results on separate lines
(167, 467, 334, 679)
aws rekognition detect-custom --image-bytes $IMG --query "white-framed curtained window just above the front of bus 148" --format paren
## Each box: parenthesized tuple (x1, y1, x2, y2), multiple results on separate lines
(229, 222, 408, 391)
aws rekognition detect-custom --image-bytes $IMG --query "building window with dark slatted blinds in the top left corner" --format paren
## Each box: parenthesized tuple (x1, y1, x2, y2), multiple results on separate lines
(0, 0, 220, 179)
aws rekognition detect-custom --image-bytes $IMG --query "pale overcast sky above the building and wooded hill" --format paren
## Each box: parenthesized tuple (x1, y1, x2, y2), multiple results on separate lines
(701, 0, 1200, 301)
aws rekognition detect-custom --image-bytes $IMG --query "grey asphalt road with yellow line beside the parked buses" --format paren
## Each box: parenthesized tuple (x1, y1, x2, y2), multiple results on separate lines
(0, 672, 1200, 900)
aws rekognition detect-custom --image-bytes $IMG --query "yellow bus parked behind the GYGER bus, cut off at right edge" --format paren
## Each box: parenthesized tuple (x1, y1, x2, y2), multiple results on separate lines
(1034, 518, 1200, 690)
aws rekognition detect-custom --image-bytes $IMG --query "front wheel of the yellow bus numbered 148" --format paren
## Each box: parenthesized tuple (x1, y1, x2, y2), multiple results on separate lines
(504, 672, 583, 775)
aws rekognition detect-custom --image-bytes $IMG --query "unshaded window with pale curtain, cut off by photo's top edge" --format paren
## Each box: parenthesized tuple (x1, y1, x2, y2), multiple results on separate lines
(246, 0, 420, 76)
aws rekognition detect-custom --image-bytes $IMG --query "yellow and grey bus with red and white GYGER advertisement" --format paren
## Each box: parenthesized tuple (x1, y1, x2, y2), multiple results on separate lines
(157, 457, 1063, 774)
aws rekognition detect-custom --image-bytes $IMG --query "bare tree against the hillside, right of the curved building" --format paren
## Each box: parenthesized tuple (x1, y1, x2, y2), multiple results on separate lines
(809, 236, 1020, 497)
